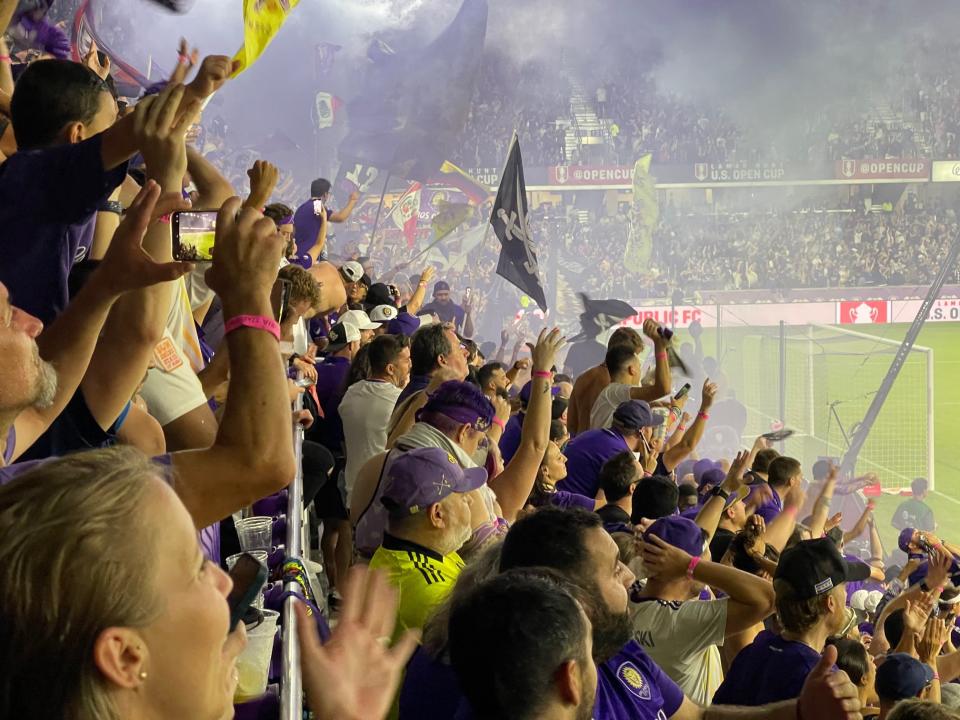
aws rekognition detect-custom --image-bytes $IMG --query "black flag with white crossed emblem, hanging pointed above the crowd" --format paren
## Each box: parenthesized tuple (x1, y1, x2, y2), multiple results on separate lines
(490, 133, 547, 312)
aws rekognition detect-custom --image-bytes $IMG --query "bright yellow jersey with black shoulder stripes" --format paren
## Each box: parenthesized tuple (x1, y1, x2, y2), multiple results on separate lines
(370, 533, 464, 639)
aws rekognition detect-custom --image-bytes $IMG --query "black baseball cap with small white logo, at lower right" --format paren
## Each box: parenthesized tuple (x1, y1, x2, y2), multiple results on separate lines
(773, 538, 870, 600)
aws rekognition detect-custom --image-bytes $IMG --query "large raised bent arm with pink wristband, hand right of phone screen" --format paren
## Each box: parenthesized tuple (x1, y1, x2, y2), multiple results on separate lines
(172, 198, 295, 527)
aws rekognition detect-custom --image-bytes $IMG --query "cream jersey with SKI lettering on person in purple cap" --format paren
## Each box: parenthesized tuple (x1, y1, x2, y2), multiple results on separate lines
(630, 598, 727, 707)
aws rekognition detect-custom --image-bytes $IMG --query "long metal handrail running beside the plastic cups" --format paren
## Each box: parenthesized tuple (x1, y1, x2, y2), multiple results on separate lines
(280, 395, 303, 720)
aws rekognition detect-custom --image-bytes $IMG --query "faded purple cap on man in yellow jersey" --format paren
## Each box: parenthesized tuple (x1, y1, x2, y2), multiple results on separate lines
(380, 448, 487, 517)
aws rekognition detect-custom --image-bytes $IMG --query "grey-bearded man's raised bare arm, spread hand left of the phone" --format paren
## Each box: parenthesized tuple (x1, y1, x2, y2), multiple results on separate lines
(14, 183, 189, 458)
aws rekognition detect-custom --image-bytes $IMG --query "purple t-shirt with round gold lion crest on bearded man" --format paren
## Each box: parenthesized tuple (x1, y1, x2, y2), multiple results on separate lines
(593, 640, 683, 720)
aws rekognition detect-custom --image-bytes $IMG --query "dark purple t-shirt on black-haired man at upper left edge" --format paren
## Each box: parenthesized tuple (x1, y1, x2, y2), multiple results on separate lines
(0, 135, 127, 325)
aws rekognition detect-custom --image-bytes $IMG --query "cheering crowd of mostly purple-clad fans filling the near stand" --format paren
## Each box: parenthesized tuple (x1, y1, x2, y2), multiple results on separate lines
(0, 14, 960, 720)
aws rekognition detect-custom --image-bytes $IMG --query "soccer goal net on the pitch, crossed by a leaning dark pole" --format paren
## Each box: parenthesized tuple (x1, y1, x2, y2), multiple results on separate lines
(722, 325, 934, 491)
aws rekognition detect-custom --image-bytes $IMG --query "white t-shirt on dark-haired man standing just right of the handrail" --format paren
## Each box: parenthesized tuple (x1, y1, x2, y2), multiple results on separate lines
(338, 380, 400, 507)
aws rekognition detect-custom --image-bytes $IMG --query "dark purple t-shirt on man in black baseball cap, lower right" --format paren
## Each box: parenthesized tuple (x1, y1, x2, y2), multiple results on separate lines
(713, 630, 820, 707)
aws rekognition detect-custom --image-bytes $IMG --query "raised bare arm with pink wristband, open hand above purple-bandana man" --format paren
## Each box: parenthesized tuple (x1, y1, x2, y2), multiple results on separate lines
(488, 328, 566, 522)
